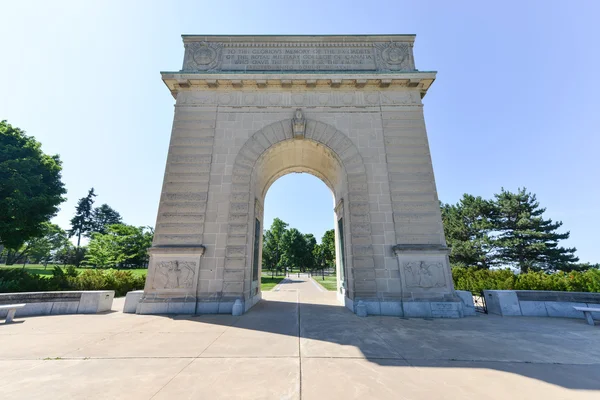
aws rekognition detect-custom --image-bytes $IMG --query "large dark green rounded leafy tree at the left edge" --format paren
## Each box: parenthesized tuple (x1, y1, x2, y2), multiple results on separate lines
(0, 121, 66, 252)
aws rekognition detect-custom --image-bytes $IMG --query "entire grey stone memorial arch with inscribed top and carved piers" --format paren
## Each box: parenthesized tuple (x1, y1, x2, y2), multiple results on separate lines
(138, 35, 462, 317)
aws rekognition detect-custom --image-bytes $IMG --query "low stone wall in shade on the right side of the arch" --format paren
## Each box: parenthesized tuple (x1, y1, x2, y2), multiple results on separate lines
(483, 290, 600, 319)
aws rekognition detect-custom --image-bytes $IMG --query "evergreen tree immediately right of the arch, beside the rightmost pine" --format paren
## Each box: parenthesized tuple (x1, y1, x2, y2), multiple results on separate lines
(441, 193, 496, 268)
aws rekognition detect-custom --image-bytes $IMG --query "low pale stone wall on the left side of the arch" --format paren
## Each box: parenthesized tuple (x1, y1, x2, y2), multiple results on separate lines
(0, 290, 115, 318)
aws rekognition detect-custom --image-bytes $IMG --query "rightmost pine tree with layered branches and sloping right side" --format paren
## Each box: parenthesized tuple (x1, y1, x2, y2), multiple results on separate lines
(494, 188, 579, 272)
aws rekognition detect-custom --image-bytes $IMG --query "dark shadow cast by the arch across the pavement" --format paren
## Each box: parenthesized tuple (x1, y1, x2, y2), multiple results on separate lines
(151, 291, 600, 390)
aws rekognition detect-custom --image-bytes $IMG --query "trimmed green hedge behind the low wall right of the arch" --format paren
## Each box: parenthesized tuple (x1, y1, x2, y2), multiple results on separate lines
(452, 267, 600, 293)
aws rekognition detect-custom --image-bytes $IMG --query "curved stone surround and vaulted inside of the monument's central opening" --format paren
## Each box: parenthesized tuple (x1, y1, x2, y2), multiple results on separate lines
(223, 115, 376, 307)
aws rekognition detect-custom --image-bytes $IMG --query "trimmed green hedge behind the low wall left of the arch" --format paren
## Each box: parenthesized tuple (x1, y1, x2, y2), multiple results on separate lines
(0, 267, 146, 296)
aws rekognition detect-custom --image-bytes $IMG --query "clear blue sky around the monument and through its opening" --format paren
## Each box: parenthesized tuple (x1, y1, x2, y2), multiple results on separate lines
(0, 0, 600, 262)
